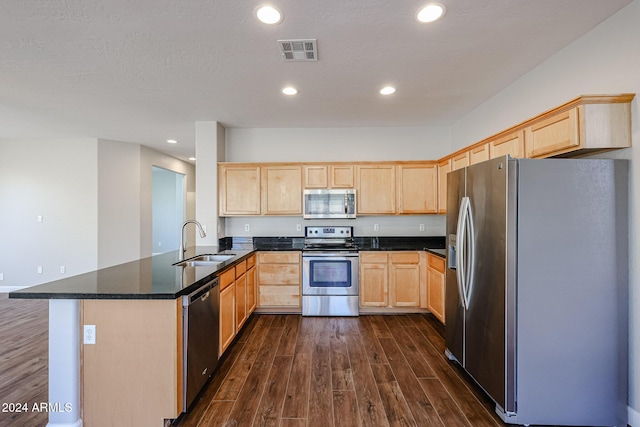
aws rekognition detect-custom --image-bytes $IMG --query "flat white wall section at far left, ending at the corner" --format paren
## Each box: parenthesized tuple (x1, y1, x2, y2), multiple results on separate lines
(0, 138, 98, 286)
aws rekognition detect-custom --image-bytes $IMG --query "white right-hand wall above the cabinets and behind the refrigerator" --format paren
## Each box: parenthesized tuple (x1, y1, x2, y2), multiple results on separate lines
(452, 0, 640, 426)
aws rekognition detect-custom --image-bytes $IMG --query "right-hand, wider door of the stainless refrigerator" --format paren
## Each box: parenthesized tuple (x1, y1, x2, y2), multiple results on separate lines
(464, 157, 515, 411)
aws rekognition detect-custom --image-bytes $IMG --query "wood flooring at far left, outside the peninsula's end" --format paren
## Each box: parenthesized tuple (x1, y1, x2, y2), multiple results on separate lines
(0, 294, 49, 427)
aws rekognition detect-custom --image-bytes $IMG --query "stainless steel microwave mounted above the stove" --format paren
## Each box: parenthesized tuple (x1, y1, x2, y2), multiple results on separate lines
(302, 188, 356, 219)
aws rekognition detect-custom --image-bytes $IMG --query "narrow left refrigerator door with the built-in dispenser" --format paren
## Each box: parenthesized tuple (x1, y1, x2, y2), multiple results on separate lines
(445, 169, 466, 365)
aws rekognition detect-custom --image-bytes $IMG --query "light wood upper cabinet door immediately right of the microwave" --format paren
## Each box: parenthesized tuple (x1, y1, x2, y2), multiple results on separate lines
(357, 165, 396, 214)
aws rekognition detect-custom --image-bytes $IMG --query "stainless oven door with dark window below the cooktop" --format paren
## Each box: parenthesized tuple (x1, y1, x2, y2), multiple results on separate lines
(302, 251, 358, 295)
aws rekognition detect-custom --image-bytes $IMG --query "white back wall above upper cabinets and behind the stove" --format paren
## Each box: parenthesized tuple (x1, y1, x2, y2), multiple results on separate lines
(225, 127, 451, 236)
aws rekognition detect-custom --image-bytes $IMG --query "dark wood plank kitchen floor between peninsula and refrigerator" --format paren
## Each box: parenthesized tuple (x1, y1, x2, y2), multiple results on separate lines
(174, 315, 504, 427)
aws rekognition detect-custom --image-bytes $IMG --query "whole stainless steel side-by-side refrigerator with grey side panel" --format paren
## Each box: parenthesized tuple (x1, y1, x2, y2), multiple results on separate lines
(445, 157, 628, 426)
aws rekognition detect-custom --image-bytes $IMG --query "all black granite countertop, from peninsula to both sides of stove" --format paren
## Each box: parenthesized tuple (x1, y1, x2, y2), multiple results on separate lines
(9, 237, 446, 299)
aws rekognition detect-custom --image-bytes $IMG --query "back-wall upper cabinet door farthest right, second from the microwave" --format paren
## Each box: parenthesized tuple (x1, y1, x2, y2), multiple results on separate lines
(397, 164, 438, 214)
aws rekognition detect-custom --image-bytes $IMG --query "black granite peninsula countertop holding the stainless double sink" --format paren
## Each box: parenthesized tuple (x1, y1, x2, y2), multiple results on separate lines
(9, 246, 254, 299)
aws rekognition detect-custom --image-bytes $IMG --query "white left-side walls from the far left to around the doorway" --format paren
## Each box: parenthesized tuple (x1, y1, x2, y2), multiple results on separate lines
(0, 138, 195, 288)
